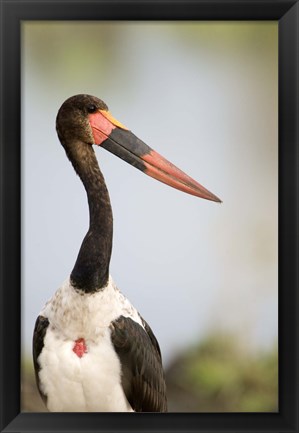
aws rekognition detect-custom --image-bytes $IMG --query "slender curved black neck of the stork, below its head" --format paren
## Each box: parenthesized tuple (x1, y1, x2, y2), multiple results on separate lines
(66, 142, 113, 293)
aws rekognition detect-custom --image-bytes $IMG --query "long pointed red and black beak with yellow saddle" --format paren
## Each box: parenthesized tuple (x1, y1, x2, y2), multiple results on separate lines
(89, 110, 221, 202)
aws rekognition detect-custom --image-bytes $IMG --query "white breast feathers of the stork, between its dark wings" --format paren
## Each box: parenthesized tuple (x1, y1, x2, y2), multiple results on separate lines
(38, 278, 143, 412)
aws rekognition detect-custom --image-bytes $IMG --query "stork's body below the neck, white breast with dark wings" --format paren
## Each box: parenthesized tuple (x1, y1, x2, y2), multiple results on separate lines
(34, 277, 166, 412)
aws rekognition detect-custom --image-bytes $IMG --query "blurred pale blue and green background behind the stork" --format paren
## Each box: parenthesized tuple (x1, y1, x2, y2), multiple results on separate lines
(22, 21, 278, 412)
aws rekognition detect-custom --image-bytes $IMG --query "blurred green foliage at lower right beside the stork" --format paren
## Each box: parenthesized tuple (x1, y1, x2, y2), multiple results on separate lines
(166, 335, 278, 412)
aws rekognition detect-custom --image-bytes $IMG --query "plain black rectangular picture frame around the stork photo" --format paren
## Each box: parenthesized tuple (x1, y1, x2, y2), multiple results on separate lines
(0, 0, 299, 433)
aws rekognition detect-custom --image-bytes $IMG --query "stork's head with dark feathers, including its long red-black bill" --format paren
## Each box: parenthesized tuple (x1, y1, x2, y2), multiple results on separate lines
(56, 95, 221, 202)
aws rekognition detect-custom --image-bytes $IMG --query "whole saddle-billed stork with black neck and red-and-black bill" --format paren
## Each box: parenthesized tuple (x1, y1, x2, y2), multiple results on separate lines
(33, 95, 220, 412)
